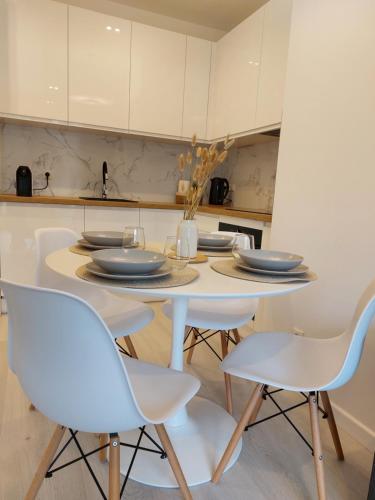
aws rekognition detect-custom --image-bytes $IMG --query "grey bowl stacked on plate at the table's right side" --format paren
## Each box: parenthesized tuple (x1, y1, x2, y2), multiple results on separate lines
(238, 250, 303, 271)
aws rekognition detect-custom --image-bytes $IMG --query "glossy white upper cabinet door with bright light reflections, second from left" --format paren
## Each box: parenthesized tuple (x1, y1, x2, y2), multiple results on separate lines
(69, 6, 131, 129)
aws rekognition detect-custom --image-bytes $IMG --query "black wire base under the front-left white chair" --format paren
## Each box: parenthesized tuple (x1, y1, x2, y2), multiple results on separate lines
(45, 426, 167, 500)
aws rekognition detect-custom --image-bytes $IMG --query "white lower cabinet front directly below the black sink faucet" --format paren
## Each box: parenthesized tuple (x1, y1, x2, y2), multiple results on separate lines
(85, 207, 139, 231)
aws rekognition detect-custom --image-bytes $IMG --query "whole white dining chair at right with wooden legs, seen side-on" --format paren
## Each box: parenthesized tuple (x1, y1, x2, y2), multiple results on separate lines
(212, 280, 375, 500)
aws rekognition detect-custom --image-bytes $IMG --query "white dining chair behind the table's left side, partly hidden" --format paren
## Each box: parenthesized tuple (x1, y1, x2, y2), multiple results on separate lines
(35, 227, 154, 358)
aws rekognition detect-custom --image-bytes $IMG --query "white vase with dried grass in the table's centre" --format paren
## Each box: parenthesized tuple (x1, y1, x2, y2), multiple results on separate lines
(177, 134, 234, 258)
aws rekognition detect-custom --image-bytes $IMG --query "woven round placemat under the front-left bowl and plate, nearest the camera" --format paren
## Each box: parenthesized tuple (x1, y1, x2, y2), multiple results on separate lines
(76, 264, 199, 288)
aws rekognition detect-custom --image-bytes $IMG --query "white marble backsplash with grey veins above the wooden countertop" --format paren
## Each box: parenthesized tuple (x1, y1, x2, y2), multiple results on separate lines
(0, 124, 277, 207)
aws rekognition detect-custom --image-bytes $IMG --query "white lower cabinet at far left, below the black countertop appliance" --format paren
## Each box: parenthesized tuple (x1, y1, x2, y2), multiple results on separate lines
(0, 203, 84, 284)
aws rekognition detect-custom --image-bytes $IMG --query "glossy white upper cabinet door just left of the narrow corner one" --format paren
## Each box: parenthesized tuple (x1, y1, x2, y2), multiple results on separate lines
(129, 23, 186, 136)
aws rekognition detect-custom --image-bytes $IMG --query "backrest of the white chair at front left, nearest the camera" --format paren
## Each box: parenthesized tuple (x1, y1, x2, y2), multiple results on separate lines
(0, 280, 148, 433)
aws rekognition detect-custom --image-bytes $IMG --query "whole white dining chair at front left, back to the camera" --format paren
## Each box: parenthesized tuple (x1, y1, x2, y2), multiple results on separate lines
(0, 280, 200, 500)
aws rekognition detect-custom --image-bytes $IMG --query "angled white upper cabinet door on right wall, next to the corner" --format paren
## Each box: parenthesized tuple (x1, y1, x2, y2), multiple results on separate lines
(212, 8, 264, 138)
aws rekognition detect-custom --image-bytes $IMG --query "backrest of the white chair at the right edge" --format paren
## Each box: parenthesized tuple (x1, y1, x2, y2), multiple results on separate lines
(327, 280, 375, 389)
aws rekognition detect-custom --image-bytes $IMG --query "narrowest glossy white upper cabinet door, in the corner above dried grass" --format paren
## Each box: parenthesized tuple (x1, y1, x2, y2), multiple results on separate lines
(182, 36, 212, 139)
